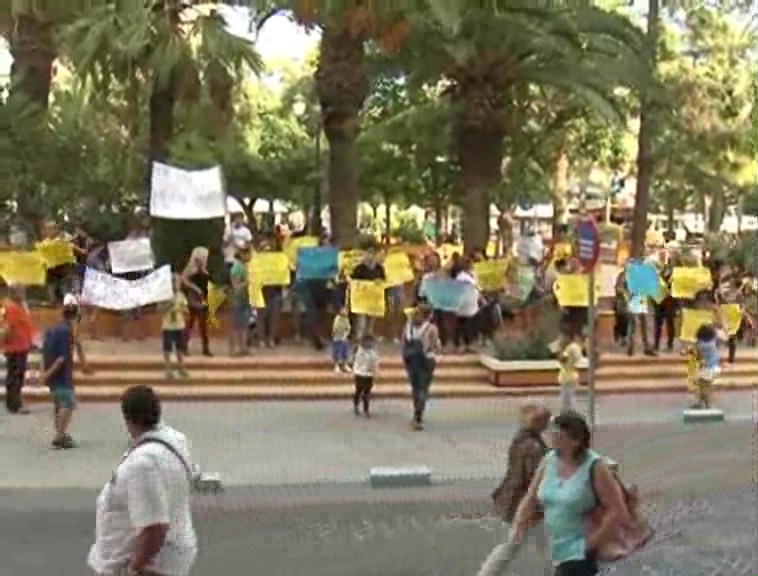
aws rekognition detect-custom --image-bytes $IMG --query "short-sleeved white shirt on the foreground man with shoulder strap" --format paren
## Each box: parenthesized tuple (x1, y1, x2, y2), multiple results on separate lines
(88, 424, 197, 576)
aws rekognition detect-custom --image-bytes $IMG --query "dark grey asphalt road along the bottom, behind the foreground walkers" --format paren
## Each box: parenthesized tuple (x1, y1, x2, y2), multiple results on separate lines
(0, 485, 758, 576)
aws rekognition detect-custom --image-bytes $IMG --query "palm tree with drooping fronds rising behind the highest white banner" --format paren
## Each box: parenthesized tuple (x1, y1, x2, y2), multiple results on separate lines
(64, 0, 263, 191)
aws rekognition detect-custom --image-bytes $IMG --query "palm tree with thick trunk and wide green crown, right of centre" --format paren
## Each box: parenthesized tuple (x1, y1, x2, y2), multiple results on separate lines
(401, 2, 641, 252)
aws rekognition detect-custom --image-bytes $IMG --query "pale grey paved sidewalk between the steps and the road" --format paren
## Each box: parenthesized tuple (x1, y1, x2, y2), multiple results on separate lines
(0, 392, 754, 489)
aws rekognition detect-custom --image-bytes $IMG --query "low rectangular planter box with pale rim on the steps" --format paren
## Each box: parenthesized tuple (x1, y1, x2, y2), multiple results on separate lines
(480, 355, 587, 388)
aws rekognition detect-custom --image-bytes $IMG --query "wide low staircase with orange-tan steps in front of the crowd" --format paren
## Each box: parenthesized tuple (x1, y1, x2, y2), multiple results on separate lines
(3, 350, 758, 402)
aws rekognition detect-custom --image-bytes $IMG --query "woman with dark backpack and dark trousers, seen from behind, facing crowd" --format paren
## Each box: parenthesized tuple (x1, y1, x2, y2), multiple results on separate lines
(402, 304, 439, 431)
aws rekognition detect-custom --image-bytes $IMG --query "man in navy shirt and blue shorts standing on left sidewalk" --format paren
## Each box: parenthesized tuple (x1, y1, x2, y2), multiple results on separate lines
(40, 304, 79, 449)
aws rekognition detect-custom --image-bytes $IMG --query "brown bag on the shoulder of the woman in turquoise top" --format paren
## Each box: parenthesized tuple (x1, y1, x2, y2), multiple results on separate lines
(587, 458, 653, 562)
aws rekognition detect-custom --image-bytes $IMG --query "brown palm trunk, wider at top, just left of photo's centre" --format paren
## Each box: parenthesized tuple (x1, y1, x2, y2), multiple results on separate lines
(316, 22, 369, 249)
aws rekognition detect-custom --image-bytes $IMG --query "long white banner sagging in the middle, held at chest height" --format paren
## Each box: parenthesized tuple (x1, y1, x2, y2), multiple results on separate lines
(82, 266, 174, 310)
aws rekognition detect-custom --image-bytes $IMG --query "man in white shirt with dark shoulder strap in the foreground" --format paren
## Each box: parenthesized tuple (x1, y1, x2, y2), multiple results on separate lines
(88, 386, 197, 576)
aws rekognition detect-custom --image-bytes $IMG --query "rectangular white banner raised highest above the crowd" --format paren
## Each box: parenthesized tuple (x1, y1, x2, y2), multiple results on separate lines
(150, 162, 226, 220)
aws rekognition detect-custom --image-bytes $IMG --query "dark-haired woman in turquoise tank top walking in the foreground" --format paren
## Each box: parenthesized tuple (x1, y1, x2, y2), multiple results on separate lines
(511, 411, 626, 576)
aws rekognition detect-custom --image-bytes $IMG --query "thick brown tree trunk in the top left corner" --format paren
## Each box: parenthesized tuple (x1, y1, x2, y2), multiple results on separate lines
(10, 14, 56, 112)
